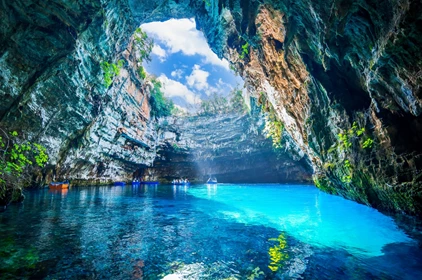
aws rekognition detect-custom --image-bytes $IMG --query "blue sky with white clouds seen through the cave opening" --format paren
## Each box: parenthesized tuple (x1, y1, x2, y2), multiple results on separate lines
(141, 19, 243, 110)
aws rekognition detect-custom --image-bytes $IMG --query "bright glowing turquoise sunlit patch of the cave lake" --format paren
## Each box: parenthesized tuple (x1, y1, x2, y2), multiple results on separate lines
(189, 184, 411, 256)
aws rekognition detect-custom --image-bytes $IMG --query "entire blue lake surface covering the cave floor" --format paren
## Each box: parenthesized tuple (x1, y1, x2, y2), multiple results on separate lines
(0, 184, 422, 279)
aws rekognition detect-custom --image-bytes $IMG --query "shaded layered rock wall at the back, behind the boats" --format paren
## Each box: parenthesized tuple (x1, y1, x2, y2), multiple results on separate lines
(145, 113, 312, 183)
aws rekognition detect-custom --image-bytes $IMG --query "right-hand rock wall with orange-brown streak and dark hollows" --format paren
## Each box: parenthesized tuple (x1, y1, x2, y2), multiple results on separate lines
(195, 1, 422, 214)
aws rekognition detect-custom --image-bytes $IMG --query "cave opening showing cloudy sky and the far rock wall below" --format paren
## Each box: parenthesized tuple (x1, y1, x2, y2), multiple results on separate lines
(132, 18, 311, 183)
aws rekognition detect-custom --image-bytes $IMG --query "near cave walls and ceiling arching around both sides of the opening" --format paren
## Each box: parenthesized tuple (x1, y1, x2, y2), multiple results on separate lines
(0, 0, 422, 215)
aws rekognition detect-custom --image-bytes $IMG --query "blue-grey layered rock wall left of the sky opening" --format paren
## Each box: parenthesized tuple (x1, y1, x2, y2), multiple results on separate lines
(0, 0, 156, 184)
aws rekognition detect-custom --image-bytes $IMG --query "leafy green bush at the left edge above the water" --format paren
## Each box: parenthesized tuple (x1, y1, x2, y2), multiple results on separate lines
(0, 129, 48, 204)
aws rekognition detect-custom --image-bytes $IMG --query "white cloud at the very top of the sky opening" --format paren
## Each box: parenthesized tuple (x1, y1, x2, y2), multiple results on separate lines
(141, 19, 229, 69)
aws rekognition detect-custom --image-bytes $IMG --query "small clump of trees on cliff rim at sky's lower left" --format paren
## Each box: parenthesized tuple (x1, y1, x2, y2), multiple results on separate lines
(149, 79, 174, 118)
